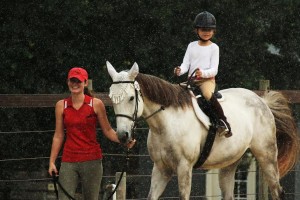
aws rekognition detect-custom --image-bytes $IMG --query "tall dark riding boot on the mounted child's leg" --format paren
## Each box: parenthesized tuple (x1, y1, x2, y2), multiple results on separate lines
(210, 95, 232, 137)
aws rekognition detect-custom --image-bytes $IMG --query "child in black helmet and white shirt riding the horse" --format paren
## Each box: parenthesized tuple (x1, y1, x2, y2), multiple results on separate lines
(174, 11, 232, 137)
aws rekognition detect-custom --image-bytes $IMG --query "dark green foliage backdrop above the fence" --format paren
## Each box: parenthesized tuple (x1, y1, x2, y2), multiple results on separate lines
(0, 0, 300, 93)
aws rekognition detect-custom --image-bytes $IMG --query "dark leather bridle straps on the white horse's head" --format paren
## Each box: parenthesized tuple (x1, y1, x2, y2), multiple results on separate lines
(112, 80, 165, 139)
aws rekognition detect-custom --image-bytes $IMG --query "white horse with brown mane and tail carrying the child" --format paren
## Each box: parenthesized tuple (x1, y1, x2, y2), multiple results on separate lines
(107, 62, 299, 200)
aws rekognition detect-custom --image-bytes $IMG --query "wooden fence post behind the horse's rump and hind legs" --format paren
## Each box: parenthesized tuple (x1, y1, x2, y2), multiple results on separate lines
(258, 80, 270, 200)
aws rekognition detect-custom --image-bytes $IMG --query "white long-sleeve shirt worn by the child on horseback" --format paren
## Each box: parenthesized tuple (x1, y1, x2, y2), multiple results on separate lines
(180, 41, 219, 78)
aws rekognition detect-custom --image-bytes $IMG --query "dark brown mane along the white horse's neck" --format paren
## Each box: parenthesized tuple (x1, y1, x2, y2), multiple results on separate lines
(136, 73, 192, 108)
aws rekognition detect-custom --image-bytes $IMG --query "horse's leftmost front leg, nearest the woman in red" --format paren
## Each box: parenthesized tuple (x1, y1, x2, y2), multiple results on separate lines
(148, 163, 173, 200)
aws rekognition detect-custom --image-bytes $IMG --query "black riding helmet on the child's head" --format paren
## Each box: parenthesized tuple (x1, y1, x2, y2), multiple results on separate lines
(194, 11, 217, 29)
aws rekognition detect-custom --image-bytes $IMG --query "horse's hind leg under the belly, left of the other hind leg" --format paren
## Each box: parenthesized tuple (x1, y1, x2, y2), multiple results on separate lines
(219, 162, 238, 200)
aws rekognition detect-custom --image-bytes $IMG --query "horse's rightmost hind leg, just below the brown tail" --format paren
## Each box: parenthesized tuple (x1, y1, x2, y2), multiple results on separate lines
(251, 142, 284, 200)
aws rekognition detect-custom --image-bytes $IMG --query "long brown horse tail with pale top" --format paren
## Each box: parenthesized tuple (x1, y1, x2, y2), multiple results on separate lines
(263, 91, 300, 177)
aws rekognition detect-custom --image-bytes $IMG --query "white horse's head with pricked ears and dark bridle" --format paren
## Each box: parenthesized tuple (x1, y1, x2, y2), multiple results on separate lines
(106, 61, 144, 143)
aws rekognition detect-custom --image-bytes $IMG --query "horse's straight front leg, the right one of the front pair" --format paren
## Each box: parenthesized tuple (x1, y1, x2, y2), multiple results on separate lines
(177, 160, 193, 200)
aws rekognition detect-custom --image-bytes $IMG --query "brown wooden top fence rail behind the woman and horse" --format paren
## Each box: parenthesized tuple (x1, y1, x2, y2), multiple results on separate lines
(0, 90, 300, 107)
